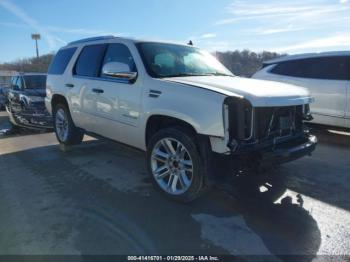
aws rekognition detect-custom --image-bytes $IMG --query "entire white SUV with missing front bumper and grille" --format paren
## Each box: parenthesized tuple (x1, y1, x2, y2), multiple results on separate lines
(45, 36, 317, 201)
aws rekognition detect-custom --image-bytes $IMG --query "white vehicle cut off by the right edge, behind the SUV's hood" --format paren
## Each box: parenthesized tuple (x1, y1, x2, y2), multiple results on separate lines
(253, 51, 350, 128)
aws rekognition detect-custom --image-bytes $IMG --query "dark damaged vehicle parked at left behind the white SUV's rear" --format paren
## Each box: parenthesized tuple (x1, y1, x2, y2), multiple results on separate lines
(6, 73, 52, 129)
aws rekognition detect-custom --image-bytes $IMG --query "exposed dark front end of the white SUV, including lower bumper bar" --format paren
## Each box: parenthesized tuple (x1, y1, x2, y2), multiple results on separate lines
(224, 97, 317, 169)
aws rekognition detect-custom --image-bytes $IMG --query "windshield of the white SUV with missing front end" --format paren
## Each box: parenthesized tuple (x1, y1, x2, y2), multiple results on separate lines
(137, 43, 233, 77)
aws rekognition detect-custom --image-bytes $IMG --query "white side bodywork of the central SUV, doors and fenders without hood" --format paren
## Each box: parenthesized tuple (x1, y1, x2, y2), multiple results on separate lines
(46, 39, 226, 150)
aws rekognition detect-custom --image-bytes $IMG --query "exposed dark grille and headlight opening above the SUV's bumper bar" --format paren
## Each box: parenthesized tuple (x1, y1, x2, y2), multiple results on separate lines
(224, 97, 311, 153)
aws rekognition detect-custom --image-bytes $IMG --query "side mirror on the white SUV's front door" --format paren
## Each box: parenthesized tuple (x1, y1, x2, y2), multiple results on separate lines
(102, 62, 137, 82)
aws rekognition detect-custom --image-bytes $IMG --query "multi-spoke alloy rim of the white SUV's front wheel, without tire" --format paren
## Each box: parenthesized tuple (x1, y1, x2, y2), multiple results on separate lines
(151, 138, 193, 195)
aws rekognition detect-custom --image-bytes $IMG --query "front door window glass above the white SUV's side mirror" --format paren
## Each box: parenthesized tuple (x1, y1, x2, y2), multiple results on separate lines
(102, 44, 137, 72)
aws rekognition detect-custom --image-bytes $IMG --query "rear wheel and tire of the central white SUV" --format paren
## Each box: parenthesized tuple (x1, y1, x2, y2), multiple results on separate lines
(53, 104, 84, 146)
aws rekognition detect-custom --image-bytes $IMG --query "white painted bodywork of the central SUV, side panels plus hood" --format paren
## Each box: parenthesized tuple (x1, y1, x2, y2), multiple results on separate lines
(46, 38, 312, 153)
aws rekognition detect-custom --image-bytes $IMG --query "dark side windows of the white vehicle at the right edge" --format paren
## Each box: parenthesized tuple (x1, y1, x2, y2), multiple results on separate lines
(270, 56, 350, 80)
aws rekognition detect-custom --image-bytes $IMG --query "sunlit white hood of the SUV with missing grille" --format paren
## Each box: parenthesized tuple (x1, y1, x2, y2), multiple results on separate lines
(164, 76, 313, 107)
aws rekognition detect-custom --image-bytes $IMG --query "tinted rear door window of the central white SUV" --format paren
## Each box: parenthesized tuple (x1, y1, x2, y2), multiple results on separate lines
(73, 44, 106, 77)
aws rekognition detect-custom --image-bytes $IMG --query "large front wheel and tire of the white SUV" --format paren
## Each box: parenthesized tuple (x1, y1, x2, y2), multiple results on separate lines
(147, 128, 204, 202)
